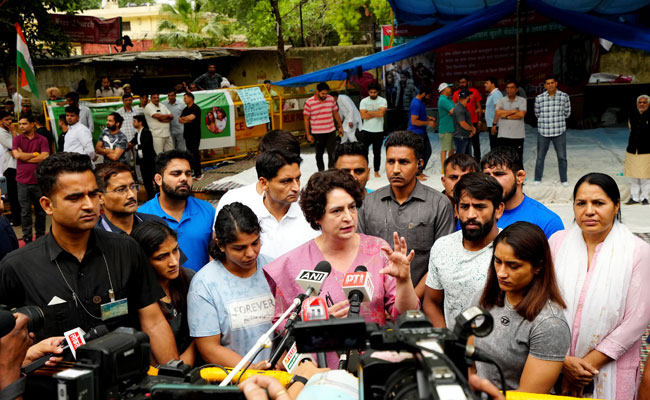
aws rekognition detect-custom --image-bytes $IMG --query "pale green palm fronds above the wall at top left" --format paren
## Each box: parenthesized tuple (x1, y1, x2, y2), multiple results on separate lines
(154, 0, 234, 48)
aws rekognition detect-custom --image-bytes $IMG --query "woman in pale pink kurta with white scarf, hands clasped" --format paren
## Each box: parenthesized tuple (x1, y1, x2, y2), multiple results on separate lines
(550, 173, 650, 400)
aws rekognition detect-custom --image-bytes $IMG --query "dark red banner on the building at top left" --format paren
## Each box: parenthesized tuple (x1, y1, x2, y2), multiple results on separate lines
(50, 14, 122, 44)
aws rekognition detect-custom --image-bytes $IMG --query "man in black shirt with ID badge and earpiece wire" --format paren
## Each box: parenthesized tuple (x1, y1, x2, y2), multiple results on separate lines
(0, 153, 178, 363)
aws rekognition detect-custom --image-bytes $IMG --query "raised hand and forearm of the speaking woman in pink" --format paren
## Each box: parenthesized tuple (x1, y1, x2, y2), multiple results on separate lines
(379, 232, 420, 313)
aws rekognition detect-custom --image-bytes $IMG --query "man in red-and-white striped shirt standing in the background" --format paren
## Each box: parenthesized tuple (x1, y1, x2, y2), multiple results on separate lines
(303, 82, 343, 171)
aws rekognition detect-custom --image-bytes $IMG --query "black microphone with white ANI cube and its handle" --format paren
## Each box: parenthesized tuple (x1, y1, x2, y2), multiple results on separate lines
(269, 260, 332, 368)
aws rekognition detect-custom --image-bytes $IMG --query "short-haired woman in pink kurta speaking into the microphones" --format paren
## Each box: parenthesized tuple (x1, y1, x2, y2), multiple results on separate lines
(264, 170, 420, 368)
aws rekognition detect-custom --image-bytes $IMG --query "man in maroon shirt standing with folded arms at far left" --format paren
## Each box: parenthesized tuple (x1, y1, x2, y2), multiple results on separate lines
(11, 116, 50, 244)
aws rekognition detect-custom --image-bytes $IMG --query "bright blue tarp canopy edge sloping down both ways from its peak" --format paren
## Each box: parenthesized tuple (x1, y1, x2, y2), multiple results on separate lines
(274, 0, 650, 86)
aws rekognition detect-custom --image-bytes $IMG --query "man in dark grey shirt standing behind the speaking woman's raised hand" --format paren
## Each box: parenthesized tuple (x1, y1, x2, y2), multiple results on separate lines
(357, 131, 454, 298)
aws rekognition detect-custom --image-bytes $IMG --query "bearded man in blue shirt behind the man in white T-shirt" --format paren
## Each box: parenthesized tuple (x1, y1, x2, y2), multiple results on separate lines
(481, 147, 564, 238)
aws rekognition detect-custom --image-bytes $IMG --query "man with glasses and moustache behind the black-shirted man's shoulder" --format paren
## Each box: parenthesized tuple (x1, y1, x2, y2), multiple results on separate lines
(95, 163, 165, 235)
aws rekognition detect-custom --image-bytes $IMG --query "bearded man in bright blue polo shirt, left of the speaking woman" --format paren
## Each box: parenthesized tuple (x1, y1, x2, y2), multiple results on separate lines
(138, 150, 216, 271)
